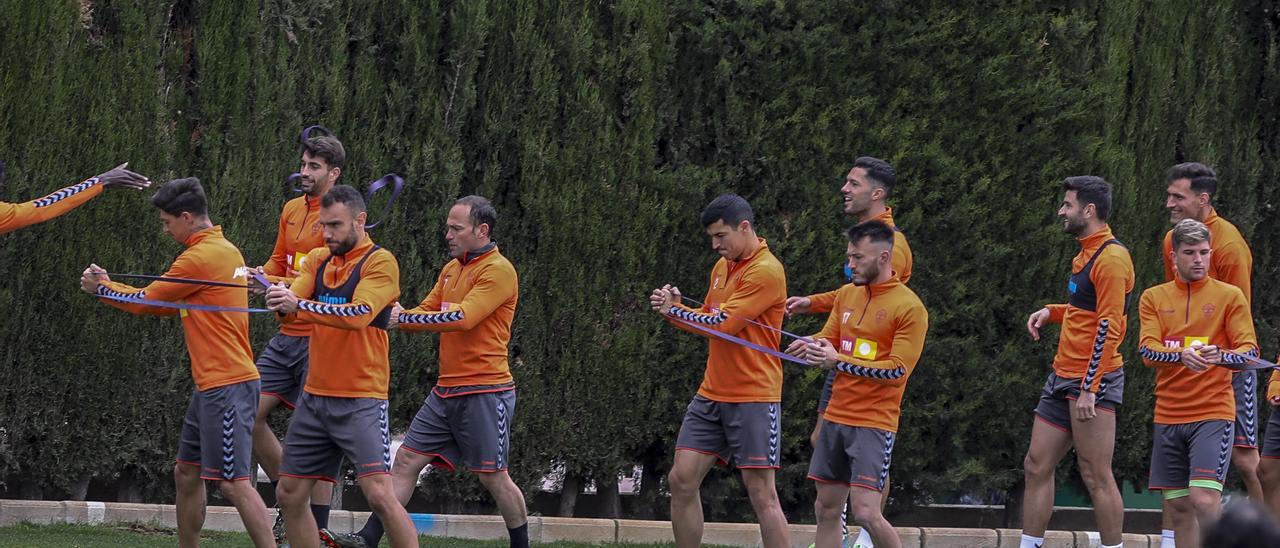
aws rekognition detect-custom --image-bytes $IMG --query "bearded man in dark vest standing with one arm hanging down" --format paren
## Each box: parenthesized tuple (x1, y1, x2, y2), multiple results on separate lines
(1021, 175, 1134, 548)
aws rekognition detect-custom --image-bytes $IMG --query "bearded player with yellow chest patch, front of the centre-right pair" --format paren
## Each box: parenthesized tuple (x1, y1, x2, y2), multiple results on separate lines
(787, 220, 929, 548)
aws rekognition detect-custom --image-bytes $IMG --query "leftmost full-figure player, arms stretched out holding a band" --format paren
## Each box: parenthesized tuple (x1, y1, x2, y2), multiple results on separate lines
(81, 178, 275, 547)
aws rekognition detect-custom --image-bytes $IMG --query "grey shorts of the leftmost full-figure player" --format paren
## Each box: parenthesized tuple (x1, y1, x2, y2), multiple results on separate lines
(178, 379, 259, 481)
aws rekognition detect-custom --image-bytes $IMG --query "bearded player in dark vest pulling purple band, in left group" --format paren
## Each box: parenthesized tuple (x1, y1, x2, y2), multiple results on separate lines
(266, 184, 417, 548)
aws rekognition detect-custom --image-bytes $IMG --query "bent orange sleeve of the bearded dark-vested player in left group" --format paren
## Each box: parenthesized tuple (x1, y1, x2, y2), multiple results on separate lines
(291, 251, 399, 330)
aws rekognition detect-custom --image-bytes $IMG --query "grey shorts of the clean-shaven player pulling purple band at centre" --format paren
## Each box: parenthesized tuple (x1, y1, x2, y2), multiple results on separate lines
(676, 396, 782, 469)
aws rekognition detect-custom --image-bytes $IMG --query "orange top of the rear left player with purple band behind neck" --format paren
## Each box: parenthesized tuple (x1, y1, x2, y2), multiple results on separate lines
(262, 195, 324, 337)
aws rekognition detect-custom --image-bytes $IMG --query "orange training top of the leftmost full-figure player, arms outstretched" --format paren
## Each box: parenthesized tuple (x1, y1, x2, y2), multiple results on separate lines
(97, 227, 257, 391)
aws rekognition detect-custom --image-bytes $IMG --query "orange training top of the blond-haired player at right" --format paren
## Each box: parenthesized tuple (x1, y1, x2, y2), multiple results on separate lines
(1138, 277, 1258, 424)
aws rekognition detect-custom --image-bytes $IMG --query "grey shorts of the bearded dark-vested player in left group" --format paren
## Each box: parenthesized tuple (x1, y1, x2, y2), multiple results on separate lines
(280, 392, 392, 483)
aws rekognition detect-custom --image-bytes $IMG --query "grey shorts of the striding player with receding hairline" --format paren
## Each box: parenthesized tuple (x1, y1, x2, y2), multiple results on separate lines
(401, 383, 516, 472)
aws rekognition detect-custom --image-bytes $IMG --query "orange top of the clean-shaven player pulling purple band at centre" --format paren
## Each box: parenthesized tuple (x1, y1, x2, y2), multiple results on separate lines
(667, 238, 787, 403)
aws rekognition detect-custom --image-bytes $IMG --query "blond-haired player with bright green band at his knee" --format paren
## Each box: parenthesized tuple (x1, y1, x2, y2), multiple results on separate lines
(1138, 219, 1258, 547)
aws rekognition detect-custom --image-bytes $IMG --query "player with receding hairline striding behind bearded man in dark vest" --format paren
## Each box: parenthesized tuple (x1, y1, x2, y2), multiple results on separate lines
(324, 196, 529, 548)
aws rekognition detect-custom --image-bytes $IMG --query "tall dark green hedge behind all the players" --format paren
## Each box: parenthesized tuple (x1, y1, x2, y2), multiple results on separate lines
(0, 0, 1280, 521)
